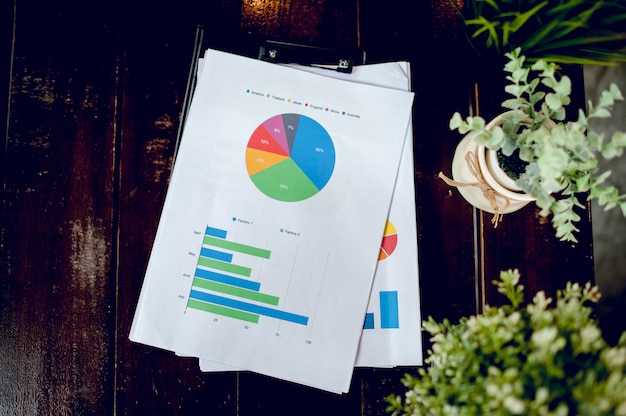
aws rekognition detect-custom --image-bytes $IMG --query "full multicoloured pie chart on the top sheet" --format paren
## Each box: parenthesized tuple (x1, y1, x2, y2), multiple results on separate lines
(246, 113, 335, 202)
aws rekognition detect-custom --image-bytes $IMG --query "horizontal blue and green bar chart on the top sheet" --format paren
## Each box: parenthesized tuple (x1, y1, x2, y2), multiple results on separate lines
(187, 226, 309, 325)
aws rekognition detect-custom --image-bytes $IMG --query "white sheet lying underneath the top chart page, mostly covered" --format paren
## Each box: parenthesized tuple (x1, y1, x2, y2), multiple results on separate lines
(200, 62, 423, 372)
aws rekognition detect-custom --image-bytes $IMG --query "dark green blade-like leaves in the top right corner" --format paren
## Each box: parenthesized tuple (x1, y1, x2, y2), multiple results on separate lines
(461, 0, 626, 65)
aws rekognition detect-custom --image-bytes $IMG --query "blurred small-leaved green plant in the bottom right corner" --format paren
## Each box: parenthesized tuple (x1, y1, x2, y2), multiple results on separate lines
(386, 270, 626, 415)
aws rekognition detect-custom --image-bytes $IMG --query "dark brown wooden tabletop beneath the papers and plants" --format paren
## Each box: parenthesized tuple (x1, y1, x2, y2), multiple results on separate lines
(0, 0, 593, 416)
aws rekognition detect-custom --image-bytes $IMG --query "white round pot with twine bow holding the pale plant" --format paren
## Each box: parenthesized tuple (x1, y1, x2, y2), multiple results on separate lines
(452, 114, 534, 221)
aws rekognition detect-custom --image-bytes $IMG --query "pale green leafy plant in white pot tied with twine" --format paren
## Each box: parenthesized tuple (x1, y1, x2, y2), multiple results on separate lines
(440, 48, 626, 242)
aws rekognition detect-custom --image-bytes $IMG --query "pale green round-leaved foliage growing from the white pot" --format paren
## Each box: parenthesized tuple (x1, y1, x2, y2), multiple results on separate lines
(450, 48, 626, 242)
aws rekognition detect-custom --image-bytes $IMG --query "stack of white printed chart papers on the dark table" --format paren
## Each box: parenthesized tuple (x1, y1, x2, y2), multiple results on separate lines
(130, 50, 422, 393)
